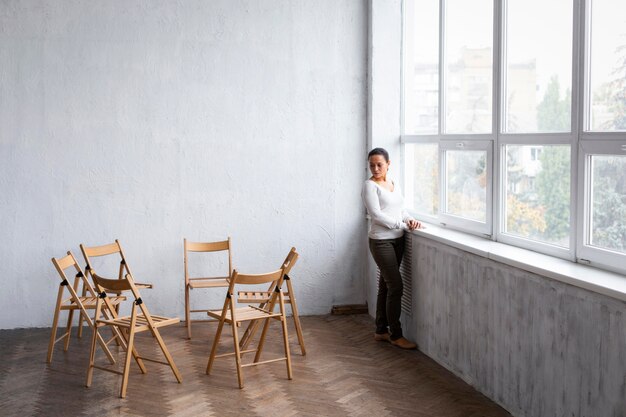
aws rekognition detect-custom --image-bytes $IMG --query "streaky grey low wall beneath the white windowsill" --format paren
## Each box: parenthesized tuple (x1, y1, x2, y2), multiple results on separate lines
(404, 236, 626, 417)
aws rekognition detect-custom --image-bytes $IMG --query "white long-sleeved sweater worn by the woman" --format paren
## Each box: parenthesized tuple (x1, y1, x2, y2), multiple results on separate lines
(361, 180, 412, 239)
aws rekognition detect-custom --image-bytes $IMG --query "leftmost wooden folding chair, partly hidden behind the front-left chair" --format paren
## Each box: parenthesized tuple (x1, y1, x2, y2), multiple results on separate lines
(46, 251, 125, 364)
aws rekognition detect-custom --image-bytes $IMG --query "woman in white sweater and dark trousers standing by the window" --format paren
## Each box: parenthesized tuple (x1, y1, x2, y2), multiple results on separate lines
(361, 148, 422, 349)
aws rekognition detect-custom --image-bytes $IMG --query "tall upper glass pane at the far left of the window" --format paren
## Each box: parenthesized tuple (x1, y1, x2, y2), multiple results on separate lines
(404, 0, 439, 135)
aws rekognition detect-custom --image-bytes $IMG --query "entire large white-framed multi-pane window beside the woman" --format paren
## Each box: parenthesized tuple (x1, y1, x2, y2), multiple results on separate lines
(401, 0, 626, 273)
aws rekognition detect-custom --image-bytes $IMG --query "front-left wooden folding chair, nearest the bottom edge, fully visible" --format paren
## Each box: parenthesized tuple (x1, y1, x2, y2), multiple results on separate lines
(85, 270, 182, 398)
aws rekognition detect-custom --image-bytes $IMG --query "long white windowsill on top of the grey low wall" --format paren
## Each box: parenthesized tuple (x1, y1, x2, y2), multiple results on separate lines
(411, 224, 626, 301)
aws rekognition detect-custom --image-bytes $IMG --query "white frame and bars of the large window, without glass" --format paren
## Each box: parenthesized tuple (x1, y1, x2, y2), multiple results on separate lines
(400, 0, 626, 274)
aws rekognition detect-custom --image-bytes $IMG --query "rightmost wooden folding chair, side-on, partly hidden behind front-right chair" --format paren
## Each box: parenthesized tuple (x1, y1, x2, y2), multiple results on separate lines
(239, 248, 306, 356)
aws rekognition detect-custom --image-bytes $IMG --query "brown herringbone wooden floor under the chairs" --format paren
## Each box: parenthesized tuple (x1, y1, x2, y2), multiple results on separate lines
(0, 315, 509, 417)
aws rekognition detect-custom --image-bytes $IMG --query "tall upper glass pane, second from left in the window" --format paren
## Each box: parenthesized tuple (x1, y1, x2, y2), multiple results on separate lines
(444, 0, 493, 133)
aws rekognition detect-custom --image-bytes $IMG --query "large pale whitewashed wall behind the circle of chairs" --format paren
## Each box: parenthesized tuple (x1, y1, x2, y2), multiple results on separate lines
(0, 0, 368, 328)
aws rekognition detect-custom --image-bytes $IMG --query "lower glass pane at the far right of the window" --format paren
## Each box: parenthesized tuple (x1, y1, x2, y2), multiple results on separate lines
(589, 155, 626, 253)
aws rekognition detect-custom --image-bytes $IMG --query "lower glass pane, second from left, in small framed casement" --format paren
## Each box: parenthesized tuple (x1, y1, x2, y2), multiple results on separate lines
(445, 151, 487, 223)
